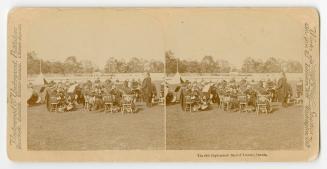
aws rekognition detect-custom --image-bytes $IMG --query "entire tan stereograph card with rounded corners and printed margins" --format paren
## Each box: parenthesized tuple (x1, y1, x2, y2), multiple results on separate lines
(7, 8, 320, 162)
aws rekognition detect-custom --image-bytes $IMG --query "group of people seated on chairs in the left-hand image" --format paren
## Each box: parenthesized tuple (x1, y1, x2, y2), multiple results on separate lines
(27, 79, 161, 112)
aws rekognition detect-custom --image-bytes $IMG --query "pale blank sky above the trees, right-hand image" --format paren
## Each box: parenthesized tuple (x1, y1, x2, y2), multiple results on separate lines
(168, 7, 304, 67)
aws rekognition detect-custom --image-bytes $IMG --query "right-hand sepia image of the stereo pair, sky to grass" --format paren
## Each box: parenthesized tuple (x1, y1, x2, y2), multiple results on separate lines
(165, 10, 306, 150)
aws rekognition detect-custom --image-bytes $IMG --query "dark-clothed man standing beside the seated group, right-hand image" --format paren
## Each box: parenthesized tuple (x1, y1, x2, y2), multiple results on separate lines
(276, 72, 288, 107)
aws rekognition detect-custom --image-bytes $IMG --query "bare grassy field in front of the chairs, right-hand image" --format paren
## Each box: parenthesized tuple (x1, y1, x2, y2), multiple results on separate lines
(166, 105, 304, 150)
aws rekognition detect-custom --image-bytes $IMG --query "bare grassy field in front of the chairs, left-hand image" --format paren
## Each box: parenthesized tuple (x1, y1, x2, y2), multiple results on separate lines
(27, 105, 165, 150)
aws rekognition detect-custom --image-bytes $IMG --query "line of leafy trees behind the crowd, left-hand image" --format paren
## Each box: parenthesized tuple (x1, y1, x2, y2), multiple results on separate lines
(27, 51, 164, 74)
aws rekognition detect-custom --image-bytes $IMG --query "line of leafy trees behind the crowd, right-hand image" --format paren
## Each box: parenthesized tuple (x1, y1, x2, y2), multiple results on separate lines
(165, 51, 303, 73)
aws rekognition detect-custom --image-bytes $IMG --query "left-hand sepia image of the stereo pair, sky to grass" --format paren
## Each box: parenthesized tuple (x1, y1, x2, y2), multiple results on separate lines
(22, 10, 165, 151)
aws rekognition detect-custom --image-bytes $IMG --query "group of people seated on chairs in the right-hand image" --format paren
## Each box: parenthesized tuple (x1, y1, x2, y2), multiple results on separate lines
(173, 79, 303, 111)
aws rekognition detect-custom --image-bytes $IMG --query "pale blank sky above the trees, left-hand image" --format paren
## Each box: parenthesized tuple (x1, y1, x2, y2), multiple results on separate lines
(28, 10, 164, 68)
